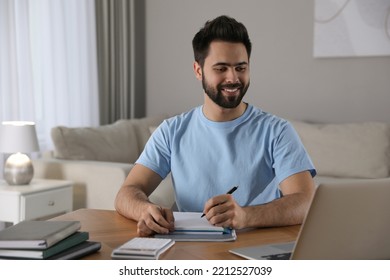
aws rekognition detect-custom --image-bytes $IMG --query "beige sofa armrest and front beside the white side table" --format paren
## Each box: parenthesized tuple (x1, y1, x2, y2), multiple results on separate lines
(33, 159, 133, 210)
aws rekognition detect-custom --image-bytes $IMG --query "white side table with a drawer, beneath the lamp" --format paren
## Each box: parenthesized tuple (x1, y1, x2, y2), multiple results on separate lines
(0, 179, 73, 224)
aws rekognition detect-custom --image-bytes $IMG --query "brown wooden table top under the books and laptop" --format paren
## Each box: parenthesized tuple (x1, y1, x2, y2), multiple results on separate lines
(53, 209, 300, 260)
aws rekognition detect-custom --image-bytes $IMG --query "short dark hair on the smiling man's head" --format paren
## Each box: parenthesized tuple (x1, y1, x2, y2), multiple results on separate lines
(192, 15, 252, 67)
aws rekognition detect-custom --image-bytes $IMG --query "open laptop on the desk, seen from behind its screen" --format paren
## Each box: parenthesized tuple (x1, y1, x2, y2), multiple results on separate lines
(230, 179, 390, 260)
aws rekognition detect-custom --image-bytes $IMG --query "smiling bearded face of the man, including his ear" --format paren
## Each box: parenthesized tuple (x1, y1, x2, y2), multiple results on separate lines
(197, 41, 250, 108)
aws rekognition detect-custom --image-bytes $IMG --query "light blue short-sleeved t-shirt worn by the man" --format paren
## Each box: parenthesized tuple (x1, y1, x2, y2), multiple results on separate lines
(136, 105, 316, 212)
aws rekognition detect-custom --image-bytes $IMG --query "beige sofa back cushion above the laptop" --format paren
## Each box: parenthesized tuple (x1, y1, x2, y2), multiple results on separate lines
(291, 121, 390, 178)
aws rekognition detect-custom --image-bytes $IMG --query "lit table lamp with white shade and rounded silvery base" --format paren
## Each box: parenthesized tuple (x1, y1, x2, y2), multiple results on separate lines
(0, 121, 39, 185)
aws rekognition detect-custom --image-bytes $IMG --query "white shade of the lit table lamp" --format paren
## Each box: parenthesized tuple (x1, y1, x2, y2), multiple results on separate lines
(0, 121, 39, 154)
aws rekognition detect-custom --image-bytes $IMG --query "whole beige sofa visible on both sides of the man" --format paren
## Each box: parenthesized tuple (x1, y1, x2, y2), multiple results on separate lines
(34, 116, 390, 209)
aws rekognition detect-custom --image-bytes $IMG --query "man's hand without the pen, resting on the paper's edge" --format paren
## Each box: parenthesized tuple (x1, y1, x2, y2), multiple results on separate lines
(137, 203, 174, 236)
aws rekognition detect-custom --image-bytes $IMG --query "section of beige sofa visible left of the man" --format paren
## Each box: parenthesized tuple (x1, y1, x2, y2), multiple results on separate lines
(34, 115, 174, 210)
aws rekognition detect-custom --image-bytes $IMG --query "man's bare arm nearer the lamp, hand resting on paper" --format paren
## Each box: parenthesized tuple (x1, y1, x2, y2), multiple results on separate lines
(115, 164, 173, 236)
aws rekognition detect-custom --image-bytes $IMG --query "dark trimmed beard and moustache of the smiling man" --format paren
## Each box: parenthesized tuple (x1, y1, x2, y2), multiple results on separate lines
(202, 76, 249, 109)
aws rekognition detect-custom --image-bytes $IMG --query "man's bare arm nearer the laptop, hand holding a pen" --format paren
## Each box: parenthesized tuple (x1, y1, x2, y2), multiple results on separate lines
(204, 171, 314, 229)
